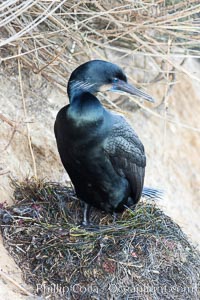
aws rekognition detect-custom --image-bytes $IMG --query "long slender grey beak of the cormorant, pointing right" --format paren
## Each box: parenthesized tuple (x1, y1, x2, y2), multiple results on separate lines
(110, 80, 155, 102)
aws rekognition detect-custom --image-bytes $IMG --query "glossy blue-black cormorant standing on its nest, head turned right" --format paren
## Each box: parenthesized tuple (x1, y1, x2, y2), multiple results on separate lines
(54, 60, 158, 225)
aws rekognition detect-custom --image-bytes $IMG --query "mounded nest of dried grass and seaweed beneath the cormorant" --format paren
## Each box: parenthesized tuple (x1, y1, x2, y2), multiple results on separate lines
(0, 179, 200, 300)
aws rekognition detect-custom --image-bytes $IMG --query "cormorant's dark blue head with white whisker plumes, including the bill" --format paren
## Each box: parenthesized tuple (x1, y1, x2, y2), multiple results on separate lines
(67, 60, 154, 102)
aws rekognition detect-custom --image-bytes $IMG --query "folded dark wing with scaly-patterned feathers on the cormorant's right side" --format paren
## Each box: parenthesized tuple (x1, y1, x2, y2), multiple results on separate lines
(104, 114, 146, 203)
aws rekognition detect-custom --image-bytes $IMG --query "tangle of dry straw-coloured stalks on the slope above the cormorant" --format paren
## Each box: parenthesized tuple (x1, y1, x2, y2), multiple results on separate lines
(0, 0, 200, 91)
